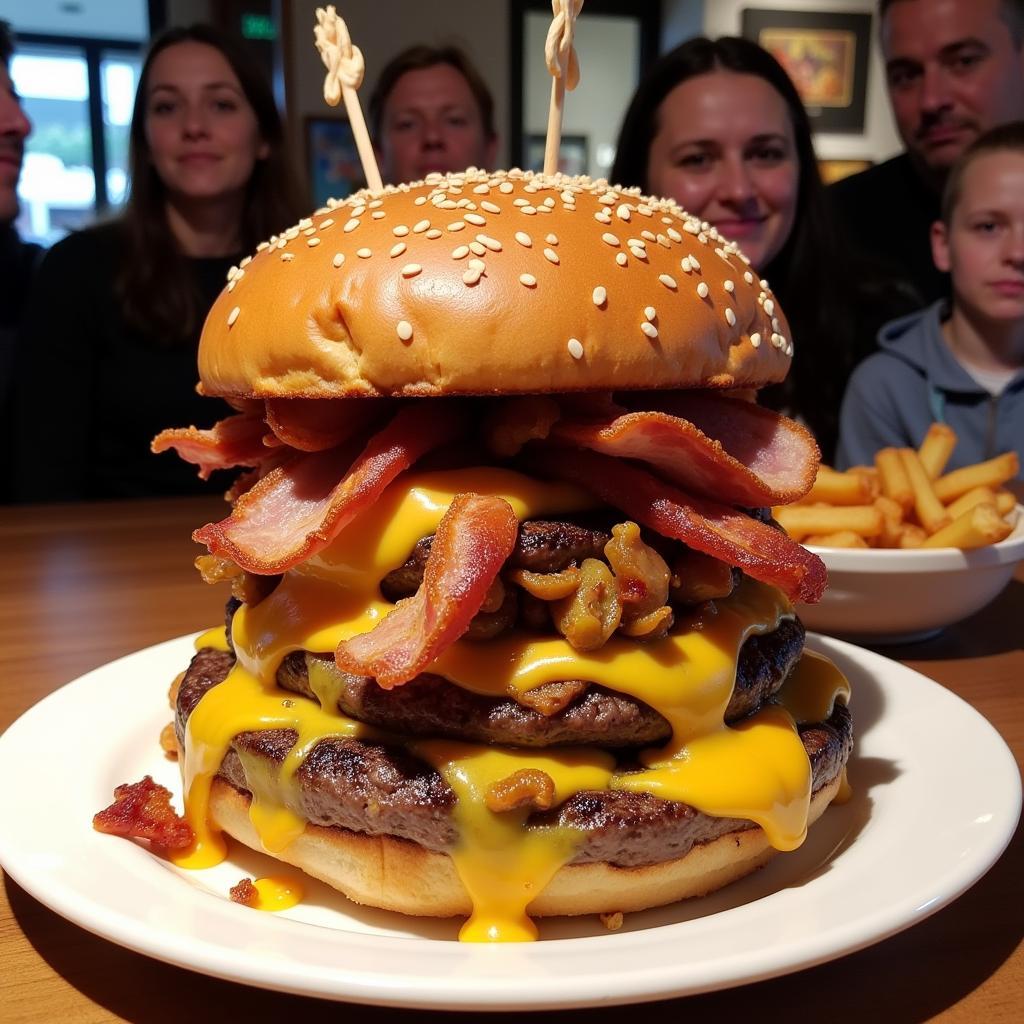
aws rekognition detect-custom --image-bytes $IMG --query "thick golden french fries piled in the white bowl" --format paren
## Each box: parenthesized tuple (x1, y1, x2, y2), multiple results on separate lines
(773, 423, 1020, 549)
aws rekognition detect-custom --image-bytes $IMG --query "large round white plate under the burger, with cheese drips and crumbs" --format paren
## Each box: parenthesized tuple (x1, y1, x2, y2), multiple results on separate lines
(0, 637, 1021, 1010)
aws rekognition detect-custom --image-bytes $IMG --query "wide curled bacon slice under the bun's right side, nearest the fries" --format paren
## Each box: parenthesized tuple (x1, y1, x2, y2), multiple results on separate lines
(552, 391, 819, 507)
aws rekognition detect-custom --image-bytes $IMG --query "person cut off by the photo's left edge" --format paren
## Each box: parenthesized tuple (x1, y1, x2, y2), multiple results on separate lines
(0, 22, 43, 432)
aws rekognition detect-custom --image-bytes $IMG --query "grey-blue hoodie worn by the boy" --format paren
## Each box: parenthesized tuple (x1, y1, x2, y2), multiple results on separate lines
(836, 302, 1024, 469)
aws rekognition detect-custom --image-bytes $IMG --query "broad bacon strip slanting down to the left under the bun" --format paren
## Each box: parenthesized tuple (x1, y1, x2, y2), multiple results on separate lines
(193, 400, 465, 574)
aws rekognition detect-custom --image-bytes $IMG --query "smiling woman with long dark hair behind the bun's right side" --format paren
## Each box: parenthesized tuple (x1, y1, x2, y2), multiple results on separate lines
(611, 37, 913, 459)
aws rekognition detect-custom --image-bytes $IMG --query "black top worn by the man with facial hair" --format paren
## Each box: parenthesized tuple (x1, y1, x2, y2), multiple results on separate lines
(825, 153, 949, 306)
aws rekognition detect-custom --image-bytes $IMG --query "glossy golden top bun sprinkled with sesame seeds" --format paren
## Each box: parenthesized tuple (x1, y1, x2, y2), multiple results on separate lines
(199, 169, 793, 398)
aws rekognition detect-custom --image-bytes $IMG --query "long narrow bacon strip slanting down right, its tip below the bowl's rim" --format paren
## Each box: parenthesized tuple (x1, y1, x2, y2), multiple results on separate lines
(528, 446, 826, 601)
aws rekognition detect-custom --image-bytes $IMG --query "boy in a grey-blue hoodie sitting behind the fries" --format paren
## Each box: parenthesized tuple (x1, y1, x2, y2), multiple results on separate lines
(838, 121, 1024, 469)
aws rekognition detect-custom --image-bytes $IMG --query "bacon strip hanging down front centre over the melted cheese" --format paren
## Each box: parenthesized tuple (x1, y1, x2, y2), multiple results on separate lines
(334, 494, 519, 690)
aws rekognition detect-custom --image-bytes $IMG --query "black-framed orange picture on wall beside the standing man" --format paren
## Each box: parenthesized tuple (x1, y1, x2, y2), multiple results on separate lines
(742, 7, 871, 133)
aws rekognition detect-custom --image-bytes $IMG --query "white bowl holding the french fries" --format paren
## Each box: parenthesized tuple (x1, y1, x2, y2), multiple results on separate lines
(797, 505, 1024, 643)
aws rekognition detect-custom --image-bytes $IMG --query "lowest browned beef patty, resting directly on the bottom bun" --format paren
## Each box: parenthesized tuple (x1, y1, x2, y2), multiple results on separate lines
(176, 648, 853, 867)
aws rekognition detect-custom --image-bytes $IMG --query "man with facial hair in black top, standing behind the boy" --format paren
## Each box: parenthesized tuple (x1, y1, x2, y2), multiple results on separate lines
(828, 0, 1024, 305)
